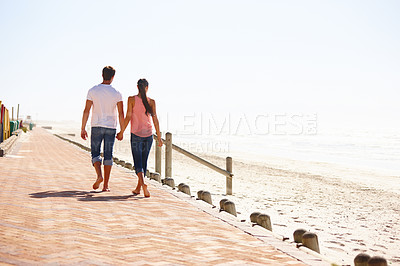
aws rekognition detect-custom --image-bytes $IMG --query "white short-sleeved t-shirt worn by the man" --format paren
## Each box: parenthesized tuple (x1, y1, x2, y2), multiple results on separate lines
(87, 84, 122, 128)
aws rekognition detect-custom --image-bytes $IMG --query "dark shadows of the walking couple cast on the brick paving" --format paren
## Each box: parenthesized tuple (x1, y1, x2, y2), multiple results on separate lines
(29, 190, 141, 201)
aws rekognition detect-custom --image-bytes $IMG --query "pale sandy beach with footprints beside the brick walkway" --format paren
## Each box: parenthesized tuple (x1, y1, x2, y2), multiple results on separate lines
(50, 123, 400, 264)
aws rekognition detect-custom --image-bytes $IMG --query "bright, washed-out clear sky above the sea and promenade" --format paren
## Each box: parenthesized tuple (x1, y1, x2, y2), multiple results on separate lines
(0, 0, 400, 130)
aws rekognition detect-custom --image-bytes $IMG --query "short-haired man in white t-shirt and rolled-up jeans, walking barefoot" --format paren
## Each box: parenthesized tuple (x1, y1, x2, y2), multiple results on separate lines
(81, 66, 124, 191)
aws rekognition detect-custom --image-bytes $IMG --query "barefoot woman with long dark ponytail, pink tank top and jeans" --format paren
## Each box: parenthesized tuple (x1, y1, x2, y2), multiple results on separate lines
(117, 79, 163, 197)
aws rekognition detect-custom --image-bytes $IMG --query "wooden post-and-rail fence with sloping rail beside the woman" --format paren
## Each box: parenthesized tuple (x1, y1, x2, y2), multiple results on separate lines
(154, 132, 233, 195)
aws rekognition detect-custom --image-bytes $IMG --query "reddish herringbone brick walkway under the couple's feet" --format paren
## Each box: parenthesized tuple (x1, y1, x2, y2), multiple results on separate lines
(0, 128, 310, 265)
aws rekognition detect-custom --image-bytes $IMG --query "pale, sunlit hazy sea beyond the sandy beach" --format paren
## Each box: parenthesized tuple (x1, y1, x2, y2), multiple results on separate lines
(38, 112, 400, 180)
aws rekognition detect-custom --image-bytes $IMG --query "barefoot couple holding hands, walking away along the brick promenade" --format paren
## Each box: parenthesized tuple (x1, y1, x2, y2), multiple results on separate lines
(81, 66, 162, 197)
